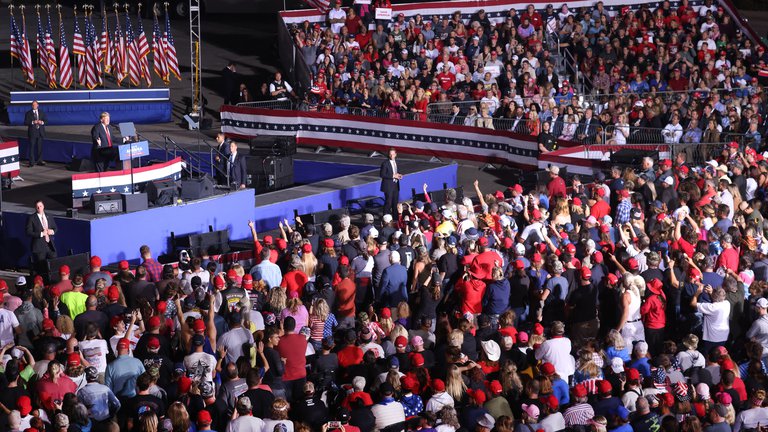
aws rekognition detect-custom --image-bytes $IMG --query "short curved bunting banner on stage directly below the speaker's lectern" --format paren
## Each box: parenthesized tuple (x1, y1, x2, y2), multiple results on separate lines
(72, 157, 184, 200)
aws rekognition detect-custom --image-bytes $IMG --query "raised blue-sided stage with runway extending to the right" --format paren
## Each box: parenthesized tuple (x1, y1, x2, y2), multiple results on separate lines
(0, 150, 457, 268)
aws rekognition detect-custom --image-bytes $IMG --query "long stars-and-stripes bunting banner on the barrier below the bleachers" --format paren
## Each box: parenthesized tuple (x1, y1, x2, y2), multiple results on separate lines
(221, 105, 539, 168)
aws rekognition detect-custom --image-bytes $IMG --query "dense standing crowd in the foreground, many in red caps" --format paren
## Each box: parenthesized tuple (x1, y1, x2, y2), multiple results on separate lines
(7, 143, 768, 432)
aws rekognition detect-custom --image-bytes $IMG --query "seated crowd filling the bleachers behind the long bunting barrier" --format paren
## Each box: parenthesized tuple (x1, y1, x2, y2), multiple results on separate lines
(280, 0, 768, 149)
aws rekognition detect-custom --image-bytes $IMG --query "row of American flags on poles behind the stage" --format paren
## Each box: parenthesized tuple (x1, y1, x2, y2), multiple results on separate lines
(11, 6, 181, 89)
